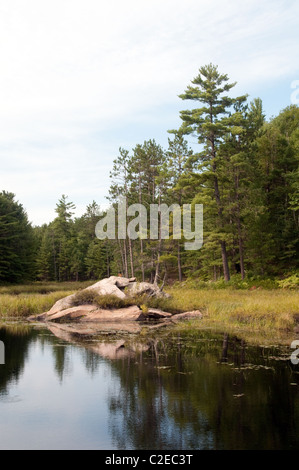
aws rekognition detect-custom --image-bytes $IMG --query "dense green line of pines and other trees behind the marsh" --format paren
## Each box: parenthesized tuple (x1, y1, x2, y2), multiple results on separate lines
(0, 64, 299, 283)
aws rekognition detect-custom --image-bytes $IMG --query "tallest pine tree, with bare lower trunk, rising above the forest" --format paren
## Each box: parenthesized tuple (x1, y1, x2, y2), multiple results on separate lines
(180, 64, 246, 281)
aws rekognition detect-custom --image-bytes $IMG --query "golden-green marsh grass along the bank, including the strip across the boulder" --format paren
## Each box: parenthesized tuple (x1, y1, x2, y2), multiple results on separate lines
(0, 282, 299, 344)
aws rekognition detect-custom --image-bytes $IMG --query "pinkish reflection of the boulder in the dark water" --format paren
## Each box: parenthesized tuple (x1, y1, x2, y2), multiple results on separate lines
(48, 322, 149, 359)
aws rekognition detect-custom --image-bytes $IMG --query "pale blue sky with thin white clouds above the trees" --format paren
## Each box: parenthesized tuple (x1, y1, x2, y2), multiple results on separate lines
(0, 0, 299, 225)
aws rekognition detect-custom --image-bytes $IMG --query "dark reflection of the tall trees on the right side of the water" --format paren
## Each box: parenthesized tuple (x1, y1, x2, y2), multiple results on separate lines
(105, 334, 299, 449)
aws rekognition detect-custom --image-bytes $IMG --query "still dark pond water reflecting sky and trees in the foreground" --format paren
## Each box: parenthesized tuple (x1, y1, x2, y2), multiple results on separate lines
(0, 325, 299, 450)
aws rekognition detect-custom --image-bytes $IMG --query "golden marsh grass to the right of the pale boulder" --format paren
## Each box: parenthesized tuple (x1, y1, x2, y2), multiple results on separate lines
(168, 288, 299, 330)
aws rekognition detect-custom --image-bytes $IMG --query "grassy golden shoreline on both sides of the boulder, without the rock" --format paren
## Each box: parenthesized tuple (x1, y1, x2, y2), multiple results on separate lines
(0, 285, 299, 344)
